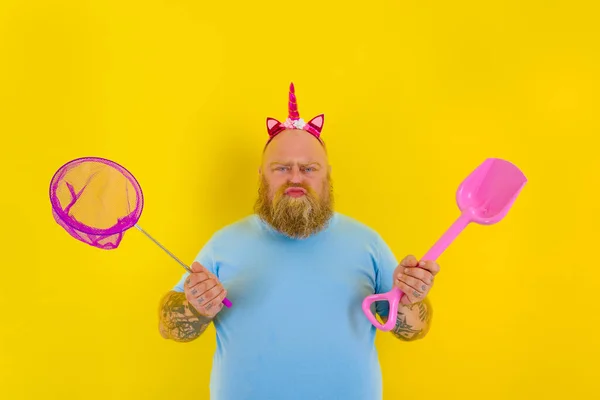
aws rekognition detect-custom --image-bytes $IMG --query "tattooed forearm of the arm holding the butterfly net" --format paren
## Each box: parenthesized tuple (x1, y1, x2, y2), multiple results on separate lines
(159, 291, 212, 342)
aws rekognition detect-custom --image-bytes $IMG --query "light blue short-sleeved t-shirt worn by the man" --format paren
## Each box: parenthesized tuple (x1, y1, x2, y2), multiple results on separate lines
(173, 213, 398, 400)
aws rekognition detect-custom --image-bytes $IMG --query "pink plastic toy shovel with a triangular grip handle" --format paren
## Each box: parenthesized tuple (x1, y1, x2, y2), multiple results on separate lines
(362, 158, 527, 331)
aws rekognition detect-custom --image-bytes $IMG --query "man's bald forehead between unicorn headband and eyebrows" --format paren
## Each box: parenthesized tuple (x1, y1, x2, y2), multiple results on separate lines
(264, 130, 327, 164)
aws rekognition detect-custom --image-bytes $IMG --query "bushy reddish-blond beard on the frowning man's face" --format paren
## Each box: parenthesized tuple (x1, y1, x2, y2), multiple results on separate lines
(254, 174, 334, 239)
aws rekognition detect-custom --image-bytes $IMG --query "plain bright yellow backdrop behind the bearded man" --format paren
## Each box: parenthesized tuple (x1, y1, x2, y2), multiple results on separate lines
(0, 0, 600, 400)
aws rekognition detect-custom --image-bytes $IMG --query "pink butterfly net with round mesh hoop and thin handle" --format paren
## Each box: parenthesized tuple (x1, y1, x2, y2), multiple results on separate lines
(50, 157, 231, 307)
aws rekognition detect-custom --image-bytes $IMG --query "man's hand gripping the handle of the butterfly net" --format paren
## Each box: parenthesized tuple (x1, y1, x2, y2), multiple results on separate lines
(183, 262, 227, 318)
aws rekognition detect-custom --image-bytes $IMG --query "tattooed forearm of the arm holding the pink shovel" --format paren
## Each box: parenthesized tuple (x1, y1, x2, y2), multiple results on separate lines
(392, 299, 431, 340)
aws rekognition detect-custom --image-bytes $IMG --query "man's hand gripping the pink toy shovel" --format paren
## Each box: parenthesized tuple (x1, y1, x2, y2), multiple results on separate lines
(394, 255, 440, 305)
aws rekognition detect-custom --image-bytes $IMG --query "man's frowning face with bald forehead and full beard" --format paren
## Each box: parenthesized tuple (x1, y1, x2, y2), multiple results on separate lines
(254, 130, 333, 238)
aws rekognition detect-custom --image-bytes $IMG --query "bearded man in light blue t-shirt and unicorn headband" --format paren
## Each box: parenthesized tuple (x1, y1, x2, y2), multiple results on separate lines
(160, 84, 439, 400)
